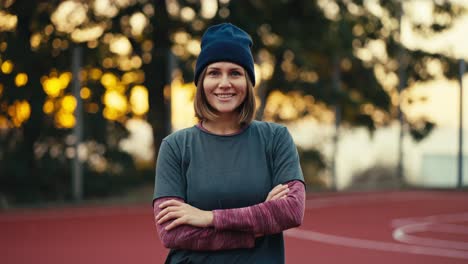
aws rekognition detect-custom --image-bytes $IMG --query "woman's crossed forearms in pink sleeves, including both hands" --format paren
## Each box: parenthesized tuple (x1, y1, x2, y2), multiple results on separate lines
(153, 180, 305, 250)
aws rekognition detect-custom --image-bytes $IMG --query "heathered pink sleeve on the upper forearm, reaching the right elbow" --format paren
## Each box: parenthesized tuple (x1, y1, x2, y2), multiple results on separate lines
(213, 180, 305, 235)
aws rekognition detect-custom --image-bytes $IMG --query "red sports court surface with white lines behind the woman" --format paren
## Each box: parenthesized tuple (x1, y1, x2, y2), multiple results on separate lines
(0, 191, 468, 264)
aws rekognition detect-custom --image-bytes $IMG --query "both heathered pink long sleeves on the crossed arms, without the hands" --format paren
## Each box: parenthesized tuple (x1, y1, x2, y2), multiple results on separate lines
(153, 180, 305, 250)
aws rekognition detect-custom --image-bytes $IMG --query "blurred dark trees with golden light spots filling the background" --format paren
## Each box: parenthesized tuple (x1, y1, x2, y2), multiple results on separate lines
(0, 0, 465, 204)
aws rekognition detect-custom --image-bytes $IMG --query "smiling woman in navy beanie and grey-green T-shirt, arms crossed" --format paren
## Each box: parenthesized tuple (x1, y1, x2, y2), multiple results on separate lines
(153, 23, 305, 264)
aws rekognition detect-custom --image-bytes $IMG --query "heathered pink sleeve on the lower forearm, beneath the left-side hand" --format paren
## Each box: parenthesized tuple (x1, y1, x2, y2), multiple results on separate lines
(153, 197, 255, 250)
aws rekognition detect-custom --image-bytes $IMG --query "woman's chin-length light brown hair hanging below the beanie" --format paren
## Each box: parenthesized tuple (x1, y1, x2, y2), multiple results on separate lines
(193, 67, 256, 126)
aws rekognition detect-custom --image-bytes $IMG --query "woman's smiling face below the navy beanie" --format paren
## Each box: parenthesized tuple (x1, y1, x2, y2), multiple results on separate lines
(203, 62, 247, 116)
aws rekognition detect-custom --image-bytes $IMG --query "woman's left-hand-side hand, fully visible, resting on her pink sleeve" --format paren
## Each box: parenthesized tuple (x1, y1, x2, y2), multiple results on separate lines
(156, 200, 213, 230)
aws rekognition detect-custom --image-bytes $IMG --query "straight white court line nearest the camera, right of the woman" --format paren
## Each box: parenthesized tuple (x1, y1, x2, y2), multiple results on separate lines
(284, 228, 468, 259)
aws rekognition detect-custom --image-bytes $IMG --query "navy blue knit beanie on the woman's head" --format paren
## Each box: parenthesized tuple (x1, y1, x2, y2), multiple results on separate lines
(195, 23, 255, 85)
